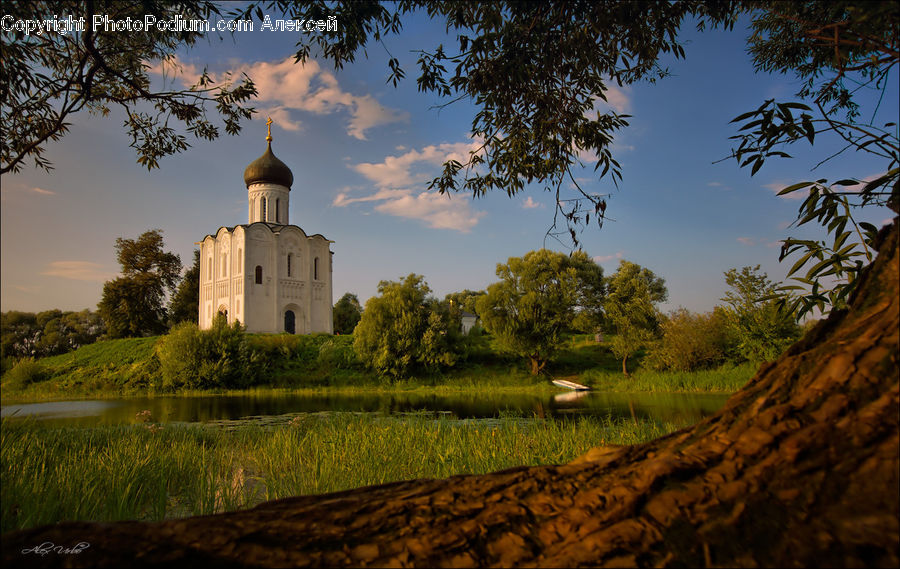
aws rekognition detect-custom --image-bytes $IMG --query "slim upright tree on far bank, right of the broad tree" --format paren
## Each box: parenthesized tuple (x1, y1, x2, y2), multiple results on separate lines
(603, 259, 668, 375)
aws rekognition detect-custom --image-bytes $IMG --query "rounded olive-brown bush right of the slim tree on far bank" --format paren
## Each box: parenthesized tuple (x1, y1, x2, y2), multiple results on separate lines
(643, 308, 738, 371)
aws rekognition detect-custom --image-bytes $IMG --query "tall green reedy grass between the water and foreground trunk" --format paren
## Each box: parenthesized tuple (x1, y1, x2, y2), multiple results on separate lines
(0, 414, 685, 532)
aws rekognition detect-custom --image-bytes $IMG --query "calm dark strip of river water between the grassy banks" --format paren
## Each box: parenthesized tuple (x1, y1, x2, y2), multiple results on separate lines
(0, 391, 729, 426)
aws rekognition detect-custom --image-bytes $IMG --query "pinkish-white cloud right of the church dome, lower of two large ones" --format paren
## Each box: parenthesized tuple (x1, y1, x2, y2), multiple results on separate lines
(332, 141, 487, 233)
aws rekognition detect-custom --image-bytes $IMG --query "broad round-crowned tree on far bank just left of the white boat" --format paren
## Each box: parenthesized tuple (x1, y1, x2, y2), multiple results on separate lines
(476, 249, 603, 375)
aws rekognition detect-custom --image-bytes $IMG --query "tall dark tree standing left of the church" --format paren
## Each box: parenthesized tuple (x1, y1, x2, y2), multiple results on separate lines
(97, 229, 181, 338)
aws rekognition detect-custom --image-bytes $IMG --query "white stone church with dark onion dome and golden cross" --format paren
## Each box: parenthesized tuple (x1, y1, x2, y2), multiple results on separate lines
(198, 119, 333, 334)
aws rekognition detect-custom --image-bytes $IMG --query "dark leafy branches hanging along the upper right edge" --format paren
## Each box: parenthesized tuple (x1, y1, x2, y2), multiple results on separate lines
(732, 1, 900, 317)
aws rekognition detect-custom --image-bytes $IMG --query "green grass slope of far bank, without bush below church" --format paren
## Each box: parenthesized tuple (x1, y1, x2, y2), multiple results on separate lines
(2, 328, 755, 403)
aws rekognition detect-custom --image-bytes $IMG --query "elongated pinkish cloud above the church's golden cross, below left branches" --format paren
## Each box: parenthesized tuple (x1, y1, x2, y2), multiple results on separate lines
(150, 57, 409, 140)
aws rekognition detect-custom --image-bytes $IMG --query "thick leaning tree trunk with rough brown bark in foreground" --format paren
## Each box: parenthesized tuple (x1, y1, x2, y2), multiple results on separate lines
(2, 223, 900, 567)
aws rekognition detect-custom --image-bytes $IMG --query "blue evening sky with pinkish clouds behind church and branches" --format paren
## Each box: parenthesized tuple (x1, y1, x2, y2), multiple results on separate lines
(0, 14, 898, 311)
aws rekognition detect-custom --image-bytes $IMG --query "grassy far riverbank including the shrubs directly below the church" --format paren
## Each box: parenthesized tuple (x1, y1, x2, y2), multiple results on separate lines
(2, 325, 757, 403)
